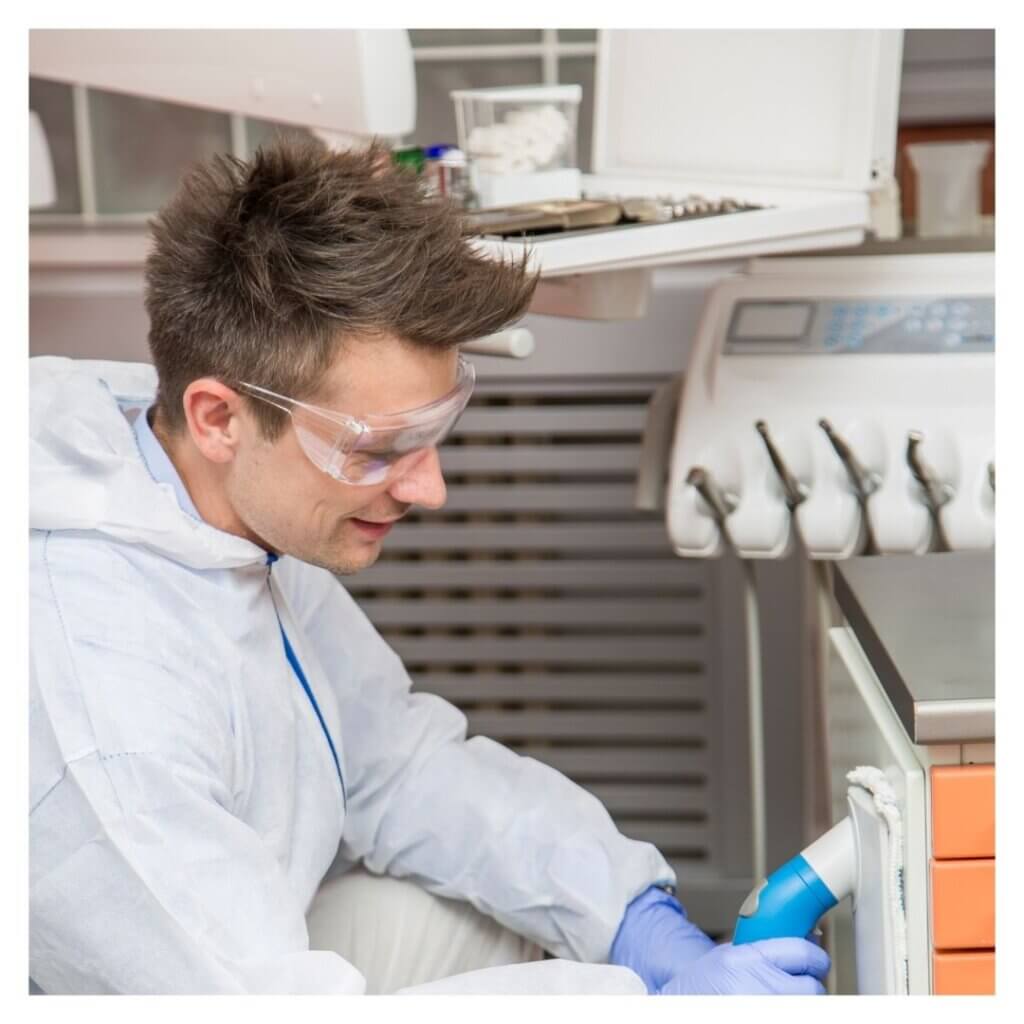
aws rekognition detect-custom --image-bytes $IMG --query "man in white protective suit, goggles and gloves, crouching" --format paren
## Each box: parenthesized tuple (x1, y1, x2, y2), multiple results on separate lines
(31, 136, 827, 993)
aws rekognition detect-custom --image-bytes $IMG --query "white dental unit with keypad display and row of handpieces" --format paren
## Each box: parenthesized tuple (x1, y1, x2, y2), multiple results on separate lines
(666, 252, 994, 559)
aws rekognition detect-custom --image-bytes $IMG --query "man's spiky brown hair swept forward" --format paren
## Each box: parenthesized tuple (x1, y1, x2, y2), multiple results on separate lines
(145, 137, 537, 439)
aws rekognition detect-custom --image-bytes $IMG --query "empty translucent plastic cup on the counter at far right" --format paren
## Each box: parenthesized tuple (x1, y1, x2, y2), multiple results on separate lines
(906, 142, 992, 239)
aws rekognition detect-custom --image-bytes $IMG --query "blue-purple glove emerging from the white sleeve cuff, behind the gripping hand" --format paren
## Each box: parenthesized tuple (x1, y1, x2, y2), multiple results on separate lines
(608, 887, 715, 994)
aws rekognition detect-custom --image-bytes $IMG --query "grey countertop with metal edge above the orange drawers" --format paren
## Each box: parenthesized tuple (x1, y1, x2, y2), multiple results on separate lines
(835, 552, 995, 743)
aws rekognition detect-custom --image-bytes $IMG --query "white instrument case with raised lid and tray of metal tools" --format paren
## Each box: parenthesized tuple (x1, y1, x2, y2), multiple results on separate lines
(467, 29, 902, 278)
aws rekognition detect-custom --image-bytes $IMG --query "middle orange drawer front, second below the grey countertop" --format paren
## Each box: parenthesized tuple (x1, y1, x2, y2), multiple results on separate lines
(932, 859, 995, 949)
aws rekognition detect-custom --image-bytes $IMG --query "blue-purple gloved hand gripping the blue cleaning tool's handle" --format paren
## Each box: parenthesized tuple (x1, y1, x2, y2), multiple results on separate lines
(657, 939, 830, 995)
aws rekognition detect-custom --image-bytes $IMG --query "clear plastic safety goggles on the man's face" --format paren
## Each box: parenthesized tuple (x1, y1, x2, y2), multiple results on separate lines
(237, 356, 476, 485)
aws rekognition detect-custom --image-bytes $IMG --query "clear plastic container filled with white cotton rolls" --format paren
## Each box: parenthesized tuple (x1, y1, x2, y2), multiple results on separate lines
(451, 85, 583, 175)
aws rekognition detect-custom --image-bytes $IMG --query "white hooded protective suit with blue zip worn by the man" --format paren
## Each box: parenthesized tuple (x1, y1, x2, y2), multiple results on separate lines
(30, 357, 675, 993)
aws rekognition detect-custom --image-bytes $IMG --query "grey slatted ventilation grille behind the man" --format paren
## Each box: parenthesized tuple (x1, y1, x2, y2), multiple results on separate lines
(345, 378, 715, 897)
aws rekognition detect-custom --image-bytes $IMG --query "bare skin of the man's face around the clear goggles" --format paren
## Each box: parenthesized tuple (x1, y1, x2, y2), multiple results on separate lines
(232, 338, 458, 574)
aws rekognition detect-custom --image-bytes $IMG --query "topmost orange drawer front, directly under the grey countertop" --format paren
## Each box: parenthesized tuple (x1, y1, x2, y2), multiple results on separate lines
(932, 765, 995, 860)
